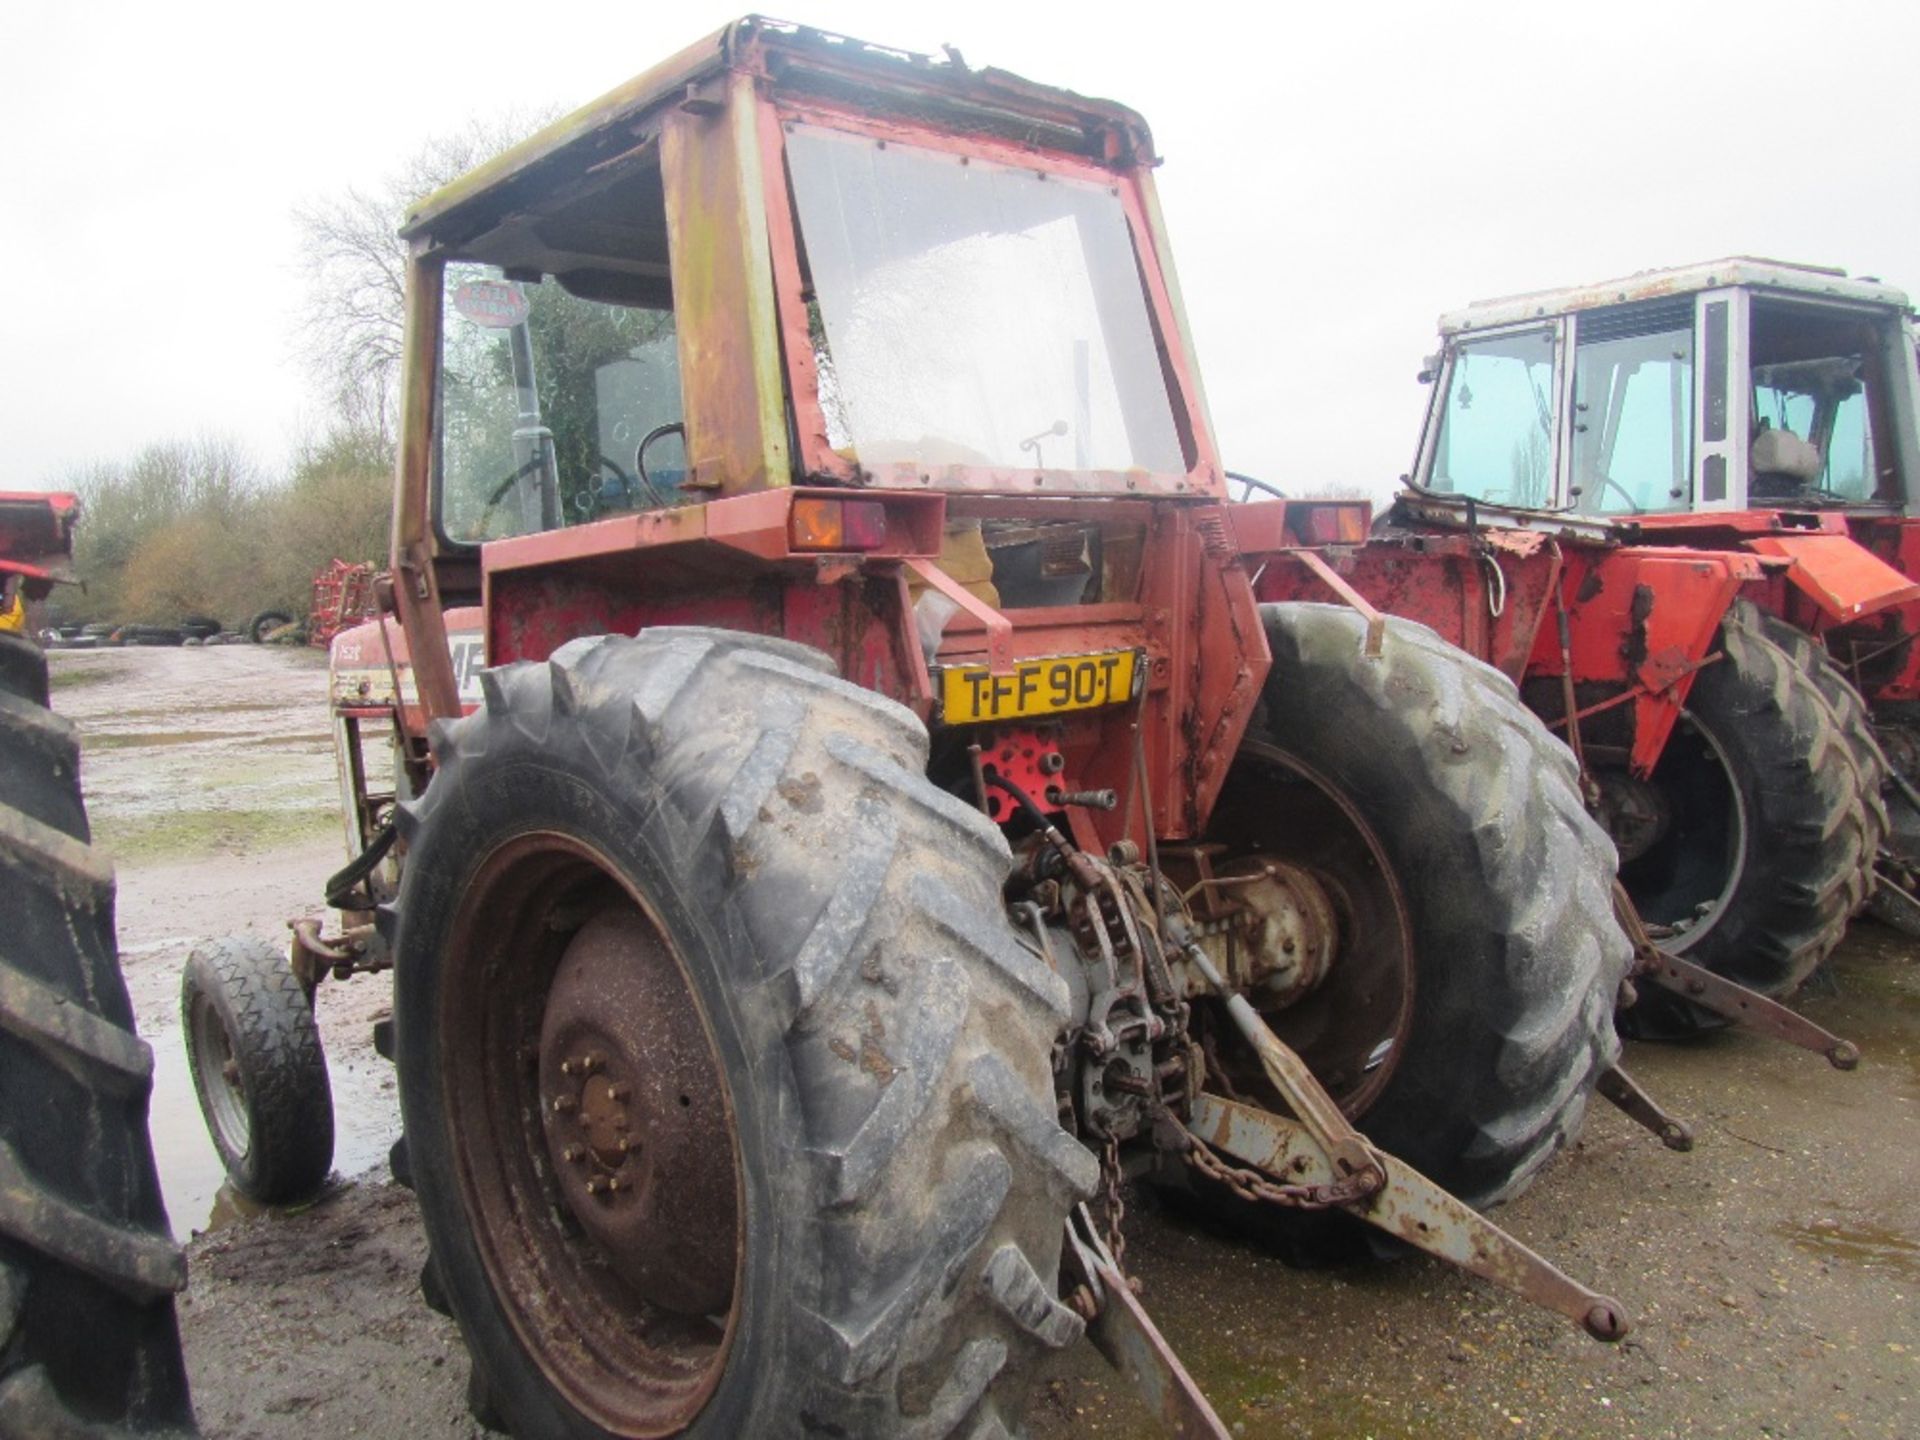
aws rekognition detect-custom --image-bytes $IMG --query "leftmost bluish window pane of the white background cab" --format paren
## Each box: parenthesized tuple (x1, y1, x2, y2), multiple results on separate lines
(1427, 328, 1553, 509)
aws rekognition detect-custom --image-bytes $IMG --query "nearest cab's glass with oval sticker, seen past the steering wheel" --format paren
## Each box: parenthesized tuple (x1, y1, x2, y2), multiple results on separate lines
(440, 263, 685, 541)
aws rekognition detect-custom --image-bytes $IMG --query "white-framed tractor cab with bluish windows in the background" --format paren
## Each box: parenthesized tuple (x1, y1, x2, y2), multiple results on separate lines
(1411, 259, 1920, 524)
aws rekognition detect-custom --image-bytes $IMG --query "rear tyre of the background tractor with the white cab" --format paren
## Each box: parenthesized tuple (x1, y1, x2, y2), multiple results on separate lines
(1620, 601, 1884, 1039)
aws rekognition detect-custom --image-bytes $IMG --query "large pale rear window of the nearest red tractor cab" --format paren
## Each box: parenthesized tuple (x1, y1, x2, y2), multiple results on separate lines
(787, 125, 1188, 474)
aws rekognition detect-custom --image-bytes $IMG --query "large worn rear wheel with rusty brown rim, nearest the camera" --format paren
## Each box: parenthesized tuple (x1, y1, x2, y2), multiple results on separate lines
(394, 628, 1098, 1440)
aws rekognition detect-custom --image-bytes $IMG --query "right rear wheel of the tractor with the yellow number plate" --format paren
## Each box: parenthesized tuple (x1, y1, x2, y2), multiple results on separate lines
(1182, 605, 1632, 1250)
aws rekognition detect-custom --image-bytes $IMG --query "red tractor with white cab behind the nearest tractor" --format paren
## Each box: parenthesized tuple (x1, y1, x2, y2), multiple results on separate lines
(1254, 259, 1920, 1033)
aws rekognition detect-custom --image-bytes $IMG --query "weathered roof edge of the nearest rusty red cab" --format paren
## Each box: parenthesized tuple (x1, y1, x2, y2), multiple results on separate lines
(401, 15, 1154, 251)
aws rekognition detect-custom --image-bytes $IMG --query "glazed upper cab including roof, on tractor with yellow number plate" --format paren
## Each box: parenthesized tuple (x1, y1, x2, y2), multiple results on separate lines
(393, 19, 1221, 603)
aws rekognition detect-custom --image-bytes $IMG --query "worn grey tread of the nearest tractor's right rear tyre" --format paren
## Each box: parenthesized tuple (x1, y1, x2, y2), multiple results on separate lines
(1256, 605, 1632, 1206)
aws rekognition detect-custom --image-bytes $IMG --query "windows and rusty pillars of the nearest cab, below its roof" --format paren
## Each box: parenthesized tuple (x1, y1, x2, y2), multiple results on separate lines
(426, 102, 1206, 549)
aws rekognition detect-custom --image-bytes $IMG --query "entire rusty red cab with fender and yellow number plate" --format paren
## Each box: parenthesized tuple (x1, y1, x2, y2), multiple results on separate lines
(394, 19, 1267, 845)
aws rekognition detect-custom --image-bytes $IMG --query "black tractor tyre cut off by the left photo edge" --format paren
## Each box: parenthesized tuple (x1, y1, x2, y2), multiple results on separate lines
(0, 634, 194, 1440)
